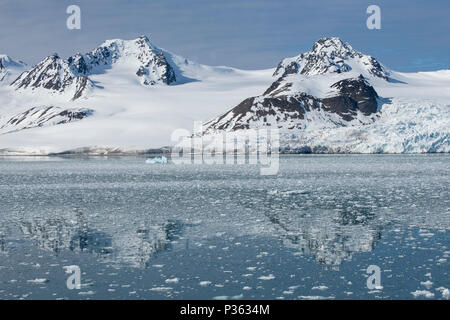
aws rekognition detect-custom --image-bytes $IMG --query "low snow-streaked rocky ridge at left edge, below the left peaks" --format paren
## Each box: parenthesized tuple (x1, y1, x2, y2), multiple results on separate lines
(0, 106, 94, 133)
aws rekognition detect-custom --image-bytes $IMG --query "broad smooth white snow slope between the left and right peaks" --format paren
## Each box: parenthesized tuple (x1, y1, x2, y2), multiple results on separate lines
(0, 36, 274, 154)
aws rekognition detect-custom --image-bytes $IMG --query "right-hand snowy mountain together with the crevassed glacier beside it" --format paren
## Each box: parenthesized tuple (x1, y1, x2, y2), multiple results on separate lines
(203, 38, 450, 152)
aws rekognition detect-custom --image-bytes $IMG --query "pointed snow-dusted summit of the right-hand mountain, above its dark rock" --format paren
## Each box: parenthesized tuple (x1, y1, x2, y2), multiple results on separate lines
(274, 38, 389, 80)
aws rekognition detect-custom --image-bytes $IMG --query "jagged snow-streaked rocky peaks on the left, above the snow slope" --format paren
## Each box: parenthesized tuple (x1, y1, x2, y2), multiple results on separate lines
(12, 36, 177, 100)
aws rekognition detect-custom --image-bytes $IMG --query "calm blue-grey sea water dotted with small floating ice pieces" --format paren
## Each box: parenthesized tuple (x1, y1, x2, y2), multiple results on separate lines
(0, 155, 450, 299)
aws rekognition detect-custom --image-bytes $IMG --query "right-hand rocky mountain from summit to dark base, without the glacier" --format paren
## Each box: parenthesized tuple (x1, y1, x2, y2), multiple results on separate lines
(205, 38, 389, 133)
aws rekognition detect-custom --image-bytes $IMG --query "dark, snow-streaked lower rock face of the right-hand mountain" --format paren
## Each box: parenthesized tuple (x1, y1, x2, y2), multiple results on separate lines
(205, 76, 378, 133)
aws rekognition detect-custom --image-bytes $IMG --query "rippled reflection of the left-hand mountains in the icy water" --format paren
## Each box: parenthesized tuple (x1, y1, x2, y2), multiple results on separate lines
(17, 212, 182, 268)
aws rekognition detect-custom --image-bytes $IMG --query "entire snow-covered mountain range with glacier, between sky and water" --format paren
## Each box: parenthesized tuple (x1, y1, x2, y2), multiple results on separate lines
(0, 36, 450, 154)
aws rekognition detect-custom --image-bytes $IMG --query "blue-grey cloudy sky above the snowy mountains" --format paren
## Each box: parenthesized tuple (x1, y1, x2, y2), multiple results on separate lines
(0, 0, 450, 71)
